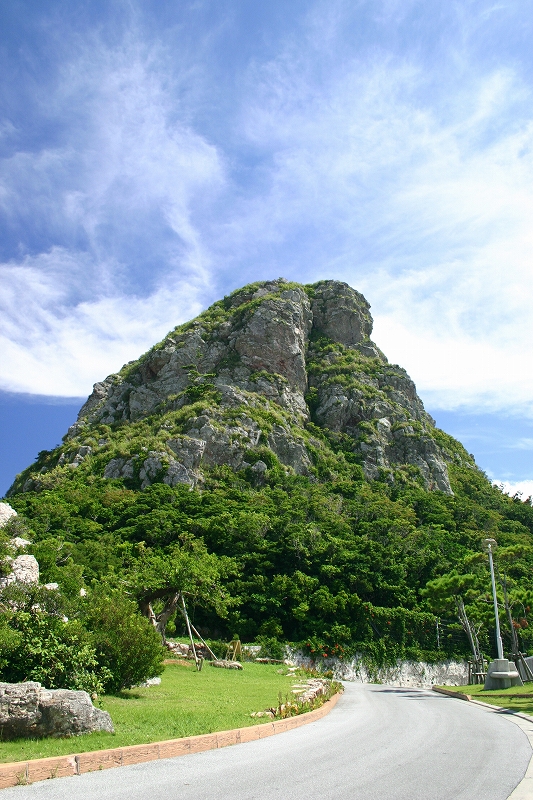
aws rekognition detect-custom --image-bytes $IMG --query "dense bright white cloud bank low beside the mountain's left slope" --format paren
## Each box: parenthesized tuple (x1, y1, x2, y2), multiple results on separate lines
(0, 251, 205, 396)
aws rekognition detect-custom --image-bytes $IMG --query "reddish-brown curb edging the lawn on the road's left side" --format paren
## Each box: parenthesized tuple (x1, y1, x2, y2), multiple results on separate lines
(0, 692, 341, 789)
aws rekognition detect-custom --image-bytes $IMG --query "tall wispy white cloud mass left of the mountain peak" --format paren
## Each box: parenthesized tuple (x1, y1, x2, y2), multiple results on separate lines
(0, 35, 225, 396)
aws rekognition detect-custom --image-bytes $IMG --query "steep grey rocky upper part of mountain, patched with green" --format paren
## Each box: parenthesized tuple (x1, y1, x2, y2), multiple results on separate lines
(6, 278, 468, 493)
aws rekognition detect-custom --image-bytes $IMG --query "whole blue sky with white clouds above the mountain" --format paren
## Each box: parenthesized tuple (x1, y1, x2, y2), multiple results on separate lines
(0, 0, 533, 493)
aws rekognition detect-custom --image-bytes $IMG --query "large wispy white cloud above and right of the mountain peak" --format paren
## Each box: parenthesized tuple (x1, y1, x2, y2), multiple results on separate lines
(214, 9, 533, 414)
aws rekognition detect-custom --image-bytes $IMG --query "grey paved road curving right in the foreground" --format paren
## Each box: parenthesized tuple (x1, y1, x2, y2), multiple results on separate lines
(1, 684, 532, 800)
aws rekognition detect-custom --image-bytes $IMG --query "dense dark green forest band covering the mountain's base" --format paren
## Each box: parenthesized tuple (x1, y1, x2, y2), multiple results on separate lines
(7, 463, 533, 664)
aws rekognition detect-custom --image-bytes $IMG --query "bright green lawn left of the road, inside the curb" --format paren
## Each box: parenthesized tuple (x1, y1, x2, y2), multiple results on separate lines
(0, 662, 296, 763)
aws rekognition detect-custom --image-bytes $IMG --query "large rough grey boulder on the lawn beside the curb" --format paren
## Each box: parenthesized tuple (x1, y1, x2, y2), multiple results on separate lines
(0, 681, 114, 739)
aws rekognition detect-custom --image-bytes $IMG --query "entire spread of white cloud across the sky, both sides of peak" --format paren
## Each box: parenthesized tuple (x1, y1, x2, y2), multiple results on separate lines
(0, 0, 533, 415)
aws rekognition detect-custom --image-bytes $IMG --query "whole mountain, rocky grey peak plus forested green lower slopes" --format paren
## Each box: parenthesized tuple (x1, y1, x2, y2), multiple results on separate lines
(1, 279, 533, 662)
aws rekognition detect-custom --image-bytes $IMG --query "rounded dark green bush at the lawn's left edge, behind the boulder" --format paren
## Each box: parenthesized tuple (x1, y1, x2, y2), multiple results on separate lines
(84, 590, 165, 693)
